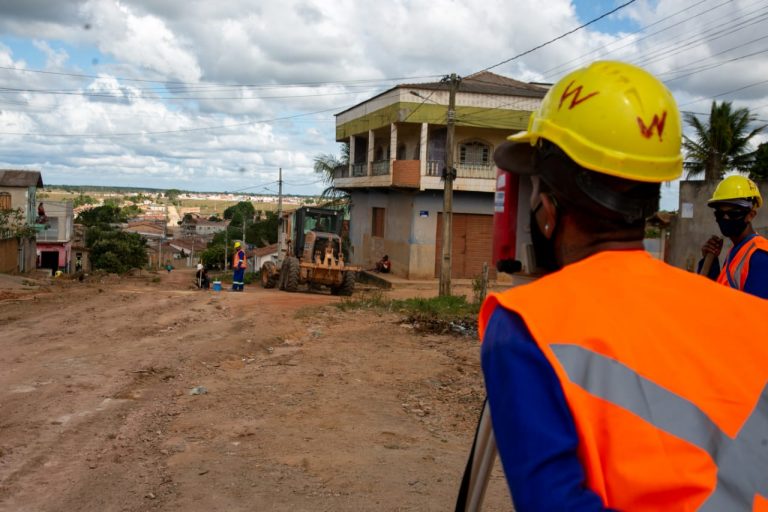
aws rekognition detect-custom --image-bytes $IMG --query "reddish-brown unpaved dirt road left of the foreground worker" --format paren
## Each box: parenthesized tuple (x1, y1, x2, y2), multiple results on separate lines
(0, 271, 511, 512)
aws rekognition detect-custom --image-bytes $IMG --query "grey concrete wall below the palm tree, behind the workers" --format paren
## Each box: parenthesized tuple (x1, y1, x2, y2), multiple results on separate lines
(667, 181, 768, 271)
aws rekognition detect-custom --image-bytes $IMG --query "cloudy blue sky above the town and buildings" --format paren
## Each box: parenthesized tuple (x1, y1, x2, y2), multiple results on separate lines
(0, 0, 768, 209)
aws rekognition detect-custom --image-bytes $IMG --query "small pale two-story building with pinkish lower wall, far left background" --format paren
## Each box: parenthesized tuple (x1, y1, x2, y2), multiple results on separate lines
(37, 201, 74, 274)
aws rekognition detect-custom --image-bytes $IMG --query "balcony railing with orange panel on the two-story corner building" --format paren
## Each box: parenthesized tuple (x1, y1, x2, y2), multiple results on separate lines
(334, 160, 496, 192)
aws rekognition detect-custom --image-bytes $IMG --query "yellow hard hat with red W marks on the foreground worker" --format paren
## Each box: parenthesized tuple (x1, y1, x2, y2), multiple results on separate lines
(508, 61, 683, 183)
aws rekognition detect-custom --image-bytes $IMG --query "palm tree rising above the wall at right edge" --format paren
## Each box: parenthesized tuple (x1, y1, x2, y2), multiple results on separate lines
(683, 101, 765, 181)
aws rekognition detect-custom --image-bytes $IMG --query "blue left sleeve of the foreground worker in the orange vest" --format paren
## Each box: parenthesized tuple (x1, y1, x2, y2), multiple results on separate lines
(481, 307, 608, 512)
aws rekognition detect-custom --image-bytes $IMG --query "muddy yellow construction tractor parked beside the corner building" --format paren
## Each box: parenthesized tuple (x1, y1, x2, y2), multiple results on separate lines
(261, 206, 360, 295)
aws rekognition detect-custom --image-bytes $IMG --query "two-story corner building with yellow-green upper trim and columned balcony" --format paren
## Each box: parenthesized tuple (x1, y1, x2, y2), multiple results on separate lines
(334, 71, 547, 279)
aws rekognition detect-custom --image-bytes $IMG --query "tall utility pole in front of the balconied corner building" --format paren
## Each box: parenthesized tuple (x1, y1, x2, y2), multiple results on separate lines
(439, 73, 459, 297)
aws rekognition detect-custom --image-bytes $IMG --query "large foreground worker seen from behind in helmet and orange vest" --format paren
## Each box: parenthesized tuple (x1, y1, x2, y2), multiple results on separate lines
(479, 61, 768, 512)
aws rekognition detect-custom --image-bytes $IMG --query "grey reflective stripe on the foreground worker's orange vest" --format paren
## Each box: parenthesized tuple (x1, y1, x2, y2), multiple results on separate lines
(551, 345, 768, 512)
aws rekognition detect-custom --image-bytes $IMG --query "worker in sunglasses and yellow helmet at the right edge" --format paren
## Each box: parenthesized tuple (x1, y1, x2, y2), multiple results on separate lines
(699, 175, 768, 299)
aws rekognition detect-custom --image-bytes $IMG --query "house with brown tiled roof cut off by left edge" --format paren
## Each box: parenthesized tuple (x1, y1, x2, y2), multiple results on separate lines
(0, 169, 43, 272)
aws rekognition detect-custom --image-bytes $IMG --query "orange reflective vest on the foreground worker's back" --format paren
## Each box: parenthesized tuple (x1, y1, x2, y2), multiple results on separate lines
(479, 251, 768, 512)
